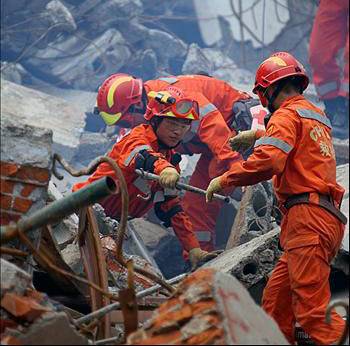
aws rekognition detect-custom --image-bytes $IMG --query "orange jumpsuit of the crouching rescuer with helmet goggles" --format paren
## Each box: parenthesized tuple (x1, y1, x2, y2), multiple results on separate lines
(73, 125, 199, 251)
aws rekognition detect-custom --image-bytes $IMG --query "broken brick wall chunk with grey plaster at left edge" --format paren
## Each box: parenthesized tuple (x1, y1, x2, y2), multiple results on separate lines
(0, 115, 52, 272)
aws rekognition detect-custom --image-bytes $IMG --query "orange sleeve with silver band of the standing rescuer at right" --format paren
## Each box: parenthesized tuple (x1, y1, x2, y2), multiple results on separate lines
(219, 110, 300, 188)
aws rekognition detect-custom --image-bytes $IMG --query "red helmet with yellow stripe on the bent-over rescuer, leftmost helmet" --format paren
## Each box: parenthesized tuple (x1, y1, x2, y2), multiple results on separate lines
(97, 73, 143, 125)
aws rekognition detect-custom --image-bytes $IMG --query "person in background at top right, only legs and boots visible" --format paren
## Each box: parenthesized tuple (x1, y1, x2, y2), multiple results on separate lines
(309, 0, 349, 139)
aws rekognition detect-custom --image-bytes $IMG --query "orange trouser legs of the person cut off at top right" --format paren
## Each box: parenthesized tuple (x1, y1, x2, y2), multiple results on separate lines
(309, 0, 349, 99)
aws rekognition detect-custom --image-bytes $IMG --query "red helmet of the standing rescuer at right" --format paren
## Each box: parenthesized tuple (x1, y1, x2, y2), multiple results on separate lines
(253, 52, 309, 107)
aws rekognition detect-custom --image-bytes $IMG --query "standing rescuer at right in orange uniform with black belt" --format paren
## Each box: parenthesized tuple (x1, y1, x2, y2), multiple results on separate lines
(206, 52, 347, 345)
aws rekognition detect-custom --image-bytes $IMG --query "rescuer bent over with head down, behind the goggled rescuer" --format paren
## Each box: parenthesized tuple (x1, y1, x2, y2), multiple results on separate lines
(93, 74, 262, 251)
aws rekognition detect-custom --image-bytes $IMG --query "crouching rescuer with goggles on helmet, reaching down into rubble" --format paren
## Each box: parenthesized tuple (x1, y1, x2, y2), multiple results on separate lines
(73, 90, 216, 267)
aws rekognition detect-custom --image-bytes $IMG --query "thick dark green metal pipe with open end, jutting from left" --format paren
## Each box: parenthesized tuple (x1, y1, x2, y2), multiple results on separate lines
(0, 177, 116, 244)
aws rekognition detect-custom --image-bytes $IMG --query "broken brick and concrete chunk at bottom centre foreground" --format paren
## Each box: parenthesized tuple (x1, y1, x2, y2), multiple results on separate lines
(127, 269, 288, 345)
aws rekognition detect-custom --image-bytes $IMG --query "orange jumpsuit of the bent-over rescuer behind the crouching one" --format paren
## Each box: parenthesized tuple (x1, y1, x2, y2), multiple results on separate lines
(144, 75, 250, 251)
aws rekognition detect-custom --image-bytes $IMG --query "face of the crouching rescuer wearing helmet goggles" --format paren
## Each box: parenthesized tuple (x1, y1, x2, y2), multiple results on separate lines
(157, 118, 191, 147)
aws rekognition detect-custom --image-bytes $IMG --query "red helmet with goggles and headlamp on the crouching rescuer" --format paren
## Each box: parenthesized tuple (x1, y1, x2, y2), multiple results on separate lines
(144, 89, 199, 120)
